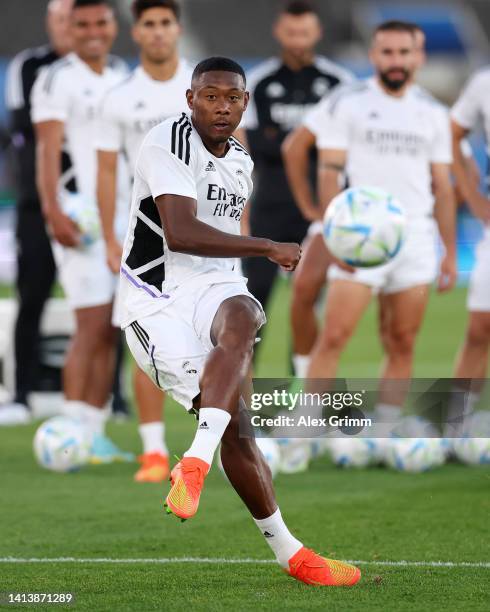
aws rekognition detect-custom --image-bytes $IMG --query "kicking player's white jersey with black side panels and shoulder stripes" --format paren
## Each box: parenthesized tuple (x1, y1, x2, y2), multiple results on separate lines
(119, 113, 253, 328)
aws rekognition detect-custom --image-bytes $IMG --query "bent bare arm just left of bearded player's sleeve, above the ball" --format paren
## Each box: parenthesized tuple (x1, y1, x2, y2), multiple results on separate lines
(281, 125, 322, 221)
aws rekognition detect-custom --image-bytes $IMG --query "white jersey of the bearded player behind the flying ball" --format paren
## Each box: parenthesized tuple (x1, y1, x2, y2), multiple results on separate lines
(304, 78, 452, 221)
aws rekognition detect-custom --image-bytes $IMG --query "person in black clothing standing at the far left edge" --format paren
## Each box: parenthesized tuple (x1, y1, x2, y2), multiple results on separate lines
(0, 0, 73, 425)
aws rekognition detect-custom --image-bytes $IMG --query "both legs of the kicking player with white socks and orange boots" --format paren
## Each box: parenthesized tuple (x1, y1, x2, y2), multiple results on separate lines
(165, 296, 361, 586)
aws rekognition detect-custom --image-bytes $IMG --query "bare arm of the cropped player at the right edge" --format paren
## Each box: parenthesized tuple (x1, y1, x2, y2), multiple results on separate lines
(451, 119, 490, 223)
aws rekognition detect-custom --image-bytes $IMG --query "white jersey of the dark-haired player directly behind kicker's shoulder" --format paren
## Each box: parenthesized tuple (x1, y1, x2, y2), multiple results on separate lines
(96, 60, 192, 174)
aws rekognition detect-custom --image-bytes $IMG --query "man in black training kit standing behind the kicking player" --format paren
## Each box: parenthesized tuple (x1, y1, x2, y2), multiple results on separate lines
(236, 0, 352, 344)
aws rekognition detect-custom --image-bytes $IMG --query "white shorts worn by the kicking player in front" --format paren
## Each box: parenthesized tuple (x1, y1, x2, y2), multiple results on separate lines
(124, 282, 266, 411)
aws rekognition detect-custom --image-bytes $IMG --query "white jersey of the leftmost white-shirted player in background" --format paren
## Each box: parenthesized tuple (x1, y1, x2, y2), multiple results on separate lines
(31, 53, 129, 225)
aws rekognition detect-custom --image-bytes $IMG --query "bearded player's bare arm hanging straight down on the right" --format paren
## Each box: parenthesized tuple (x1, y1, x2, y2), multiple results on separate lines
(431, 163, 457, 291)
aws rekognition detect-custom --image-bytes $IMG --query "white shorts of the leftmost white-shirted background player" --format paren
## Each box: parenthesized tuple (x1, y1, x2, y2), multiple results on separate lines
(53, 240, 117, 310)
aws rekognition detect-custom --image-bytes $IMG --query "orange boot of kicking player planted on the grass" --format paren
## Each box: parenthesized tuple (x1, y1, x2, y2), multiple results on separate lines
(286, 546, 361, 586)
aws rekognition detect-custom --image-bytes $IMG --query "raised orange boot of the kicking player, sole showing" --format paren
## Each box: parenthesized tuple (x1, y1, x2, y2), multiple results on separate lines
(164, 457, 210, 521)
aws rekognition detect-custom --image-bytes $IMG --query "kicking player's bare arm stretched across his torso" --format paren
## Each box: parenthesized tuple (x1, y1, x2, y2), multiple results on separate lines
(155, 195, 301, 271)
